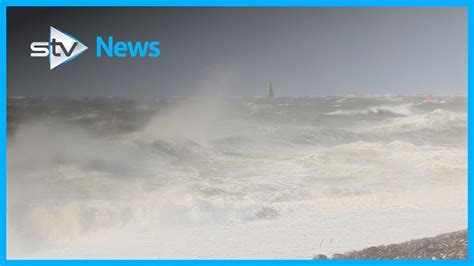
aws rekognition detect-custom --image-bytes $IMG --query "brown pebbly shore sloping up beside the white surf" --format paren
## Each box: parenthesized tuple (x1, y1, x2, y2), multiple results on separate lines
(313, 230, 467, 260)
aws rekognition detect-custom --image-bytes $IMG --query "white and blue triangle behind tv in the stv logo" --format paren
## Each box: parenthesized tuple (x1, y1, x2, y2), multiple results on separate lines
(49, 27, 87, 69)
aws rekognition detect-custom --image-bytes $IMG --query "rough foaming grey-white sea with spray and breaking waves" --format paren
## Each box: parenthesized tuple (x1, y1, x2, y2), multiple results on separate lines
(7, 95, 467, 259)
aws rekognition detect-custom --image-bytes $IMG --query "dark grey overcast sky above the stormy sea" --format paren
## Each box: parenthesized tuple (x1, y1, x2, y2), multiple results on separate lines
(7, 7, 467, 97)
